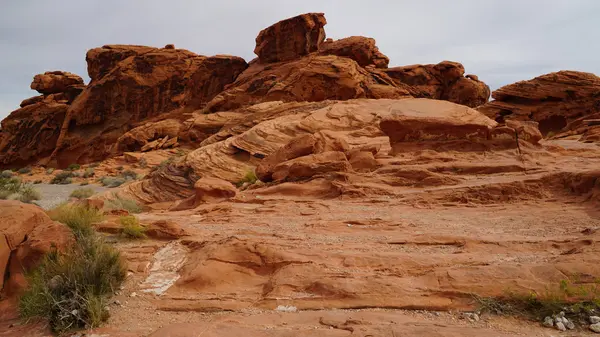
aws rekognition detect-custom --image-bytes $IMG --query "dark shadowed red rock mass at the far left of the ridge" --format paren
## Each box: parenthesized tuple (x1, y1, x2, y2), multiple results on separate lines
(0, 45, 247, 167)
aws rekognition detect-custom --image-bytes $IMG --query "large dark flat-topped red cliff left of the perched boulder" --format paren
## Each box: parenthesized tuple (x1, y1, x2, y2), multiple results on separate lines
(47, 46, 246, 167)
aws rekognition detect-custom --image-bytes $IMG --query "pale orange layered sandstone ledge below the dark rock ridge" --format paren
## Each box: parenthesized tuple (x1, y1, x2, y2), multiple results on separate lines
(122, 98, 506, 203)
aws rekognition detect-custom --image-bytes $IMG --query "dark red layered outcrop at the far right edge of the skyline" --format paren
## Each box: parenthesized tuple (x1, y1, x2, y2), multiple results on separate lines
(478, 71, 600, 135)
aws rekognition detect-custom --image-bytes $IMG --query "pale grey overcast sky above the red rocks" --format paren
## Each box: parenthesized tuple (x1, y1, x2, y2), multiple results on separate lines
(0, 0, 600, 119)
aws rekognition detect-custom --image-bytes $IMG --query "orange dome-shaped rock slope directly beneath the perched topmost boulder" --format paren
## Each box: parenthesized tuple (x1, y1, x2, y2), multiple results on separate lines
(206, 55, 410, 112)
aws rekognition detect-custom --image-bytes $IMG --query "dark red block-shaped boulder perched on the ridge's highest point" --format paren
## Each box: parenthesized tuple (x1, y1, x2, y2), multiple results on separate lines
(254, 13, 327, 63)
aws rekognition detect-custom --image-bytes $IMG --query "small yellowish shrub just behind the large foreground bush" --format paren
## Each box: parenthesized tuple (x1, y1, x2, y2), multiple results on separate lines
(48, 204, 104, 236)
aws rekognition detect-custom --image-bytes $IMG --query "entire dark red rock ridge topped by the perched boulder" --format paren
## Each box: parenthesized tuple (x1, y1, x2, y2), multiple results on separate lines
(0, 13, 487, 167)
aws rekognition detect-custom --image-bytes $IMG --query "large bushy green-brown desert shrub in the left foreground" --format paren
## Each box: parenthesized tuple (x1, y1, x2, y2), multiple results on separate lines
(19, 234, 126, 333)
